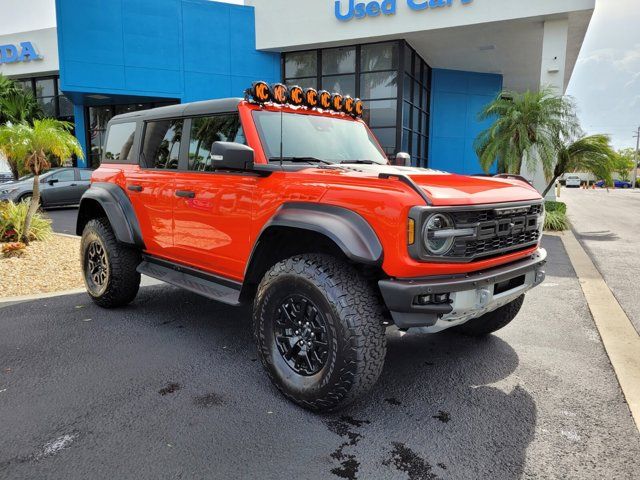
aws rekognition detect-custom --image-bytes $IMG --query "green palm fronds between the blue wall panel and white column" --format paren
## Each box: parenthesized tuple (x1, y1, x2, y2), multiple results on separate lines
(475, 88, 579, 178)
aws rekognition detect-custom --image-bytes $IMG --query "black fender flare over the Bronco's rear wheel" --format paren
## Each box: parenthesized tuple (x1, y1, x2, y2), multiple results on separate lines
(76, 182, 145, 249)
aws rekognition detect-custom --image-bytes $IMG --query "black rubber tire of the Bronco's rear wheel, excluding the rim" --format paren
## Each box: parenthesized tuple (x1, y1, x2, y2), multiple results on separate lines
(80, 218, 141, 308)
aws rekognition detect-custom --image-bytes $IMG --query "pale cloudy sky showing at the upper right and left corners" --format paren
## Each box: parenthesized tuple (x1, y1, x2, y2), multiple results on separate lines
(0, 0, 640, 148)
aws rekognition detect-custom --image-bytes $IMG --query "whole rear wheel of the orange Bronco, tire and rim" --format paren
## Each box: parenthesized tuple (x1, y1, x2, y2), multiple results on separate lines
(80, 218, 140, 308)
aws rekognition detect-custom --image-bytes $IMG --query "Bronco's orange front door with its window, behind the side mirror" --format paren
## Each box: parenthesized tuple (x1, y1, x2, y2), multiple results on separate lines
(173, 113, 260, 281)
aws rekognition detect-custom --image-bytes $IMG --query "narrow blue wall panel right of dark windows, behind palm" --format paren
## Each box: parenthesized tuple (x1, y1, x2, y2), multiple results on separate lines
(429, 69, 502, 174)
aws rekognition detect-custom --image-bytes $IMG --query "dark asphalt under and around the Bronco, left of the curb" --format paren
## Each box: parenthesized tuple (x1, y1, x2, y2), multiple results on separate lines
(0, 237, 640, 480)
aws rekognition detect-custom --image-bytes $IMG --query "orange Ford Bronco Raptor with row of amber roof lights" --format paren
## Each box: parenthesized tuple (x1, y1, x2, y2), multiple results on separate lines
(77, 82, 546, 410)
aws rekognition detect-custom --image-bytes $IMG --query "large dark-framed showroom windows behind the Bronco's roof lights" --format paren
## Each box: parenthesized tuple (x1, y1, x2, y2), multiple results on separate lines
(282, 41, 431, 166)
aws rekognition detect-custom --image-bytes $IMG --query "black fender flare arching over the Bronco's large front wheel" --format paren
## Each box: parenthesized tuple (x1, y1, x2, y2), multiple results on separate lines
(249, 202, 383, 265)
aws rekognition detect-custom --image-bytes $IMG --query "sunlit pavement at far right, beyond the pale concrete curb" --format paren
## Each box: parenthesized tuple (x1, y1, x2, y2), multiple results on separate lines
(559, 189, 640, 333)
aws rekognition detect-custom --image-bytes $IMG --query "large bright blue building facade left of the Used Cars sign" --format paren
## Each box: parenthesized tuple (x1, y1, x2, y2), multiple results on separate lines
(56, 0, 280, 165)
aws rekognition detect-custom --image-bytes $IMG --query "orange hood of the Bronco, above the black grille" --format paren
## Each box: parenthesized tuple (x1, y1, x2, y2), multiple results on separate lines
(324, 164, 542, 206)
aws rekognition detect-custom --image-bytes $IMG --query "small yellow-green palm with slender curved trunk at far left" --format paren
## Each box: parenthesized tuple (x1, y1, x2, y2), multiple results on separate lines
(0, 118, 84, 244)
